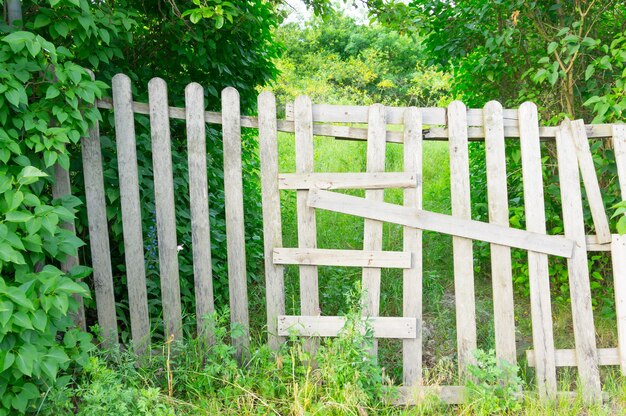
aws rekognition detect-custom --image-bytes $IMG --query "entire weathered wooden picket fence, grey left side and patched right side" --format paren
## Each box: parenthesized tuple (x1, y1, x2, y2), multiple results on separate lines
(70, 74, 626, 403)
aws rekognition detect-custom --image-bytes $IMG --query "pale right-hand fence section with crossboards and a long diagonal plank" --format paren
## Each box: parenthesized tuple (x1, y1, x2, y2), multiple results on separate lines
(259, 93, 626, 403)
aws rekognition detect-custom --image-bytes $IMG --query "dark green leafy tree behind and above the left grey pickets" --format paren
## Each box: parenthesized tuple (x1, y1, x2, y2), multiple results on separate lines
(9, 0, 280, 340)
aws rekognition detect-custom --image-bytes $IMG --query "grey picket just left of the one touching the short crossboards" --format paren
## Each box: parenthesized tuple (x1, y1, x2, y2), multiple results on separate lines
(222, 87, 250, 358)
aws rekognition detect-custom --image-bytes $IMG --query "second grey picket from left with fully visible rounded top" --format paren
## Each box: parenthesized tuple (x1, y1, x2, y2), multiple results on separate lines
(148, 78, 183, 340)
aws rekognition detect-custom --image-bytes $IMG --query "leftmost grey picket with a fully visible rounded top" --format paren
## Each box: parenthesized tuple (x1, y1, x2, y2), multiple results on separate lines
(112, 74, 150, 354)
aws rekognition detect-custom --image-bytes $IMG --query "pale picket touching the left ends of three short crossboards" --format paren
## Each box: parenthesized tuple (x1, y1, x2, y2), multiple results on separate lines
(258, 91, 285, 350)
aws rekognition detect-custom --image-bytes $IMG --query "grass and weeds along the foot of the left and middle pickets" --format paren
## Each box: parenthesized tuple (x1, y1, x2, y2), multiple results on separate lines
(36, 302, 386, 415)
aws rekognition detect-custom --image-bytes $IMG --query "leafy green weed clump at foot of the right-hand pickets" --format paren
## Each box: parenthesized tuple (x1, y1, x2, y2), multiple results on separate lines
(466, 350, 524, 415)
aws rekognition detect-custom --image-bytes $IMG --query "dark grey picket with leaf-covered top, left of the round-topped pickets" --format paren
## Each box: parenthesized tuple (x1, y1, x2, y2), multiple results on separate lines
(80, 105, 119, 348)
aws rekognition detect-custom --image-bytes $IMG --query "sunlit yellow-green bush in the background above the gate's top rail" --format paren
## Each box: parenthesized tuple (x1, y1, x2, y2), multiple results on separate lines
(274, 13, 450, 106)
